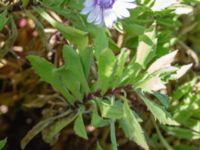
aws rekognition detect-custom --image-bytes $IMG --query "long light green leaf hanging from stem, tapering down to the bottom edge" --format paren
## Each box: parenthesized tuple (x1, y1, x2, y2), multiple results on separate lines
(119, 101, 149, 149)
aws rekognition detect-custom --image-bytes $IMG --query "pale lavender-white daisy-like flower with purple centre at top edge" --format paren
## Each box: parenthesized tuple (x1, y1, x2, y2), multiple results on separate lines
(81, 0, 136, 28)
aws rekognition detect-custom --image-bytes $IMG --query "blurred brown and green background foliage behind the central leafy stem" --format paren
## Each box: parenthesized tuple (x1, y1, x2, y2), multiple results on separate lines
(0, 0, 200, 150)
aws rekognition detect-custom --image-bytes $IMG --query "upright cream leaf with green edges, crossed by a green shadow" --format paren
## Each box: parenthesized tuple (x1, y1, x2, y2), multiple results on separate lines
(136, 23, 157, 68)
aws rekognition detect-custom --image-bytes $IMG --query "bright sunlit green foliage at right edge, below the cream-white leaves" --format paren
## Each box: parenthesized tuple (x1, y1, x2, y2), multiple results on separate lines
(164, 77, 200, 140)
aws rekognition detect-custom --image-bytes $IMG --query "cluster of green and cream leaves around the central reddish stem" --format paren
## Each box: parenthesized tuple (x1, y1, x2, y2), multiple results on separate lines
(23, 3, 194, 149)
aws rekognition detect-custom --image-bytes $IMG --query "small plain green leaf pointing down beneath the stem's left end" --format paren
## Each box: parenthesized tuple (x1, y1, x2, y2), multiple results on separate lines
(74, 113, 88, 140)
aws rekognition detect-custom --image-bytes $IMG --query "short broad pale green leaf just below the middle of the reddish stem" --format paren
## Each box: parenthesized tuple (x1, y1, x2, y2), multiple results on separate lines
(98, 100, 123, 120)
